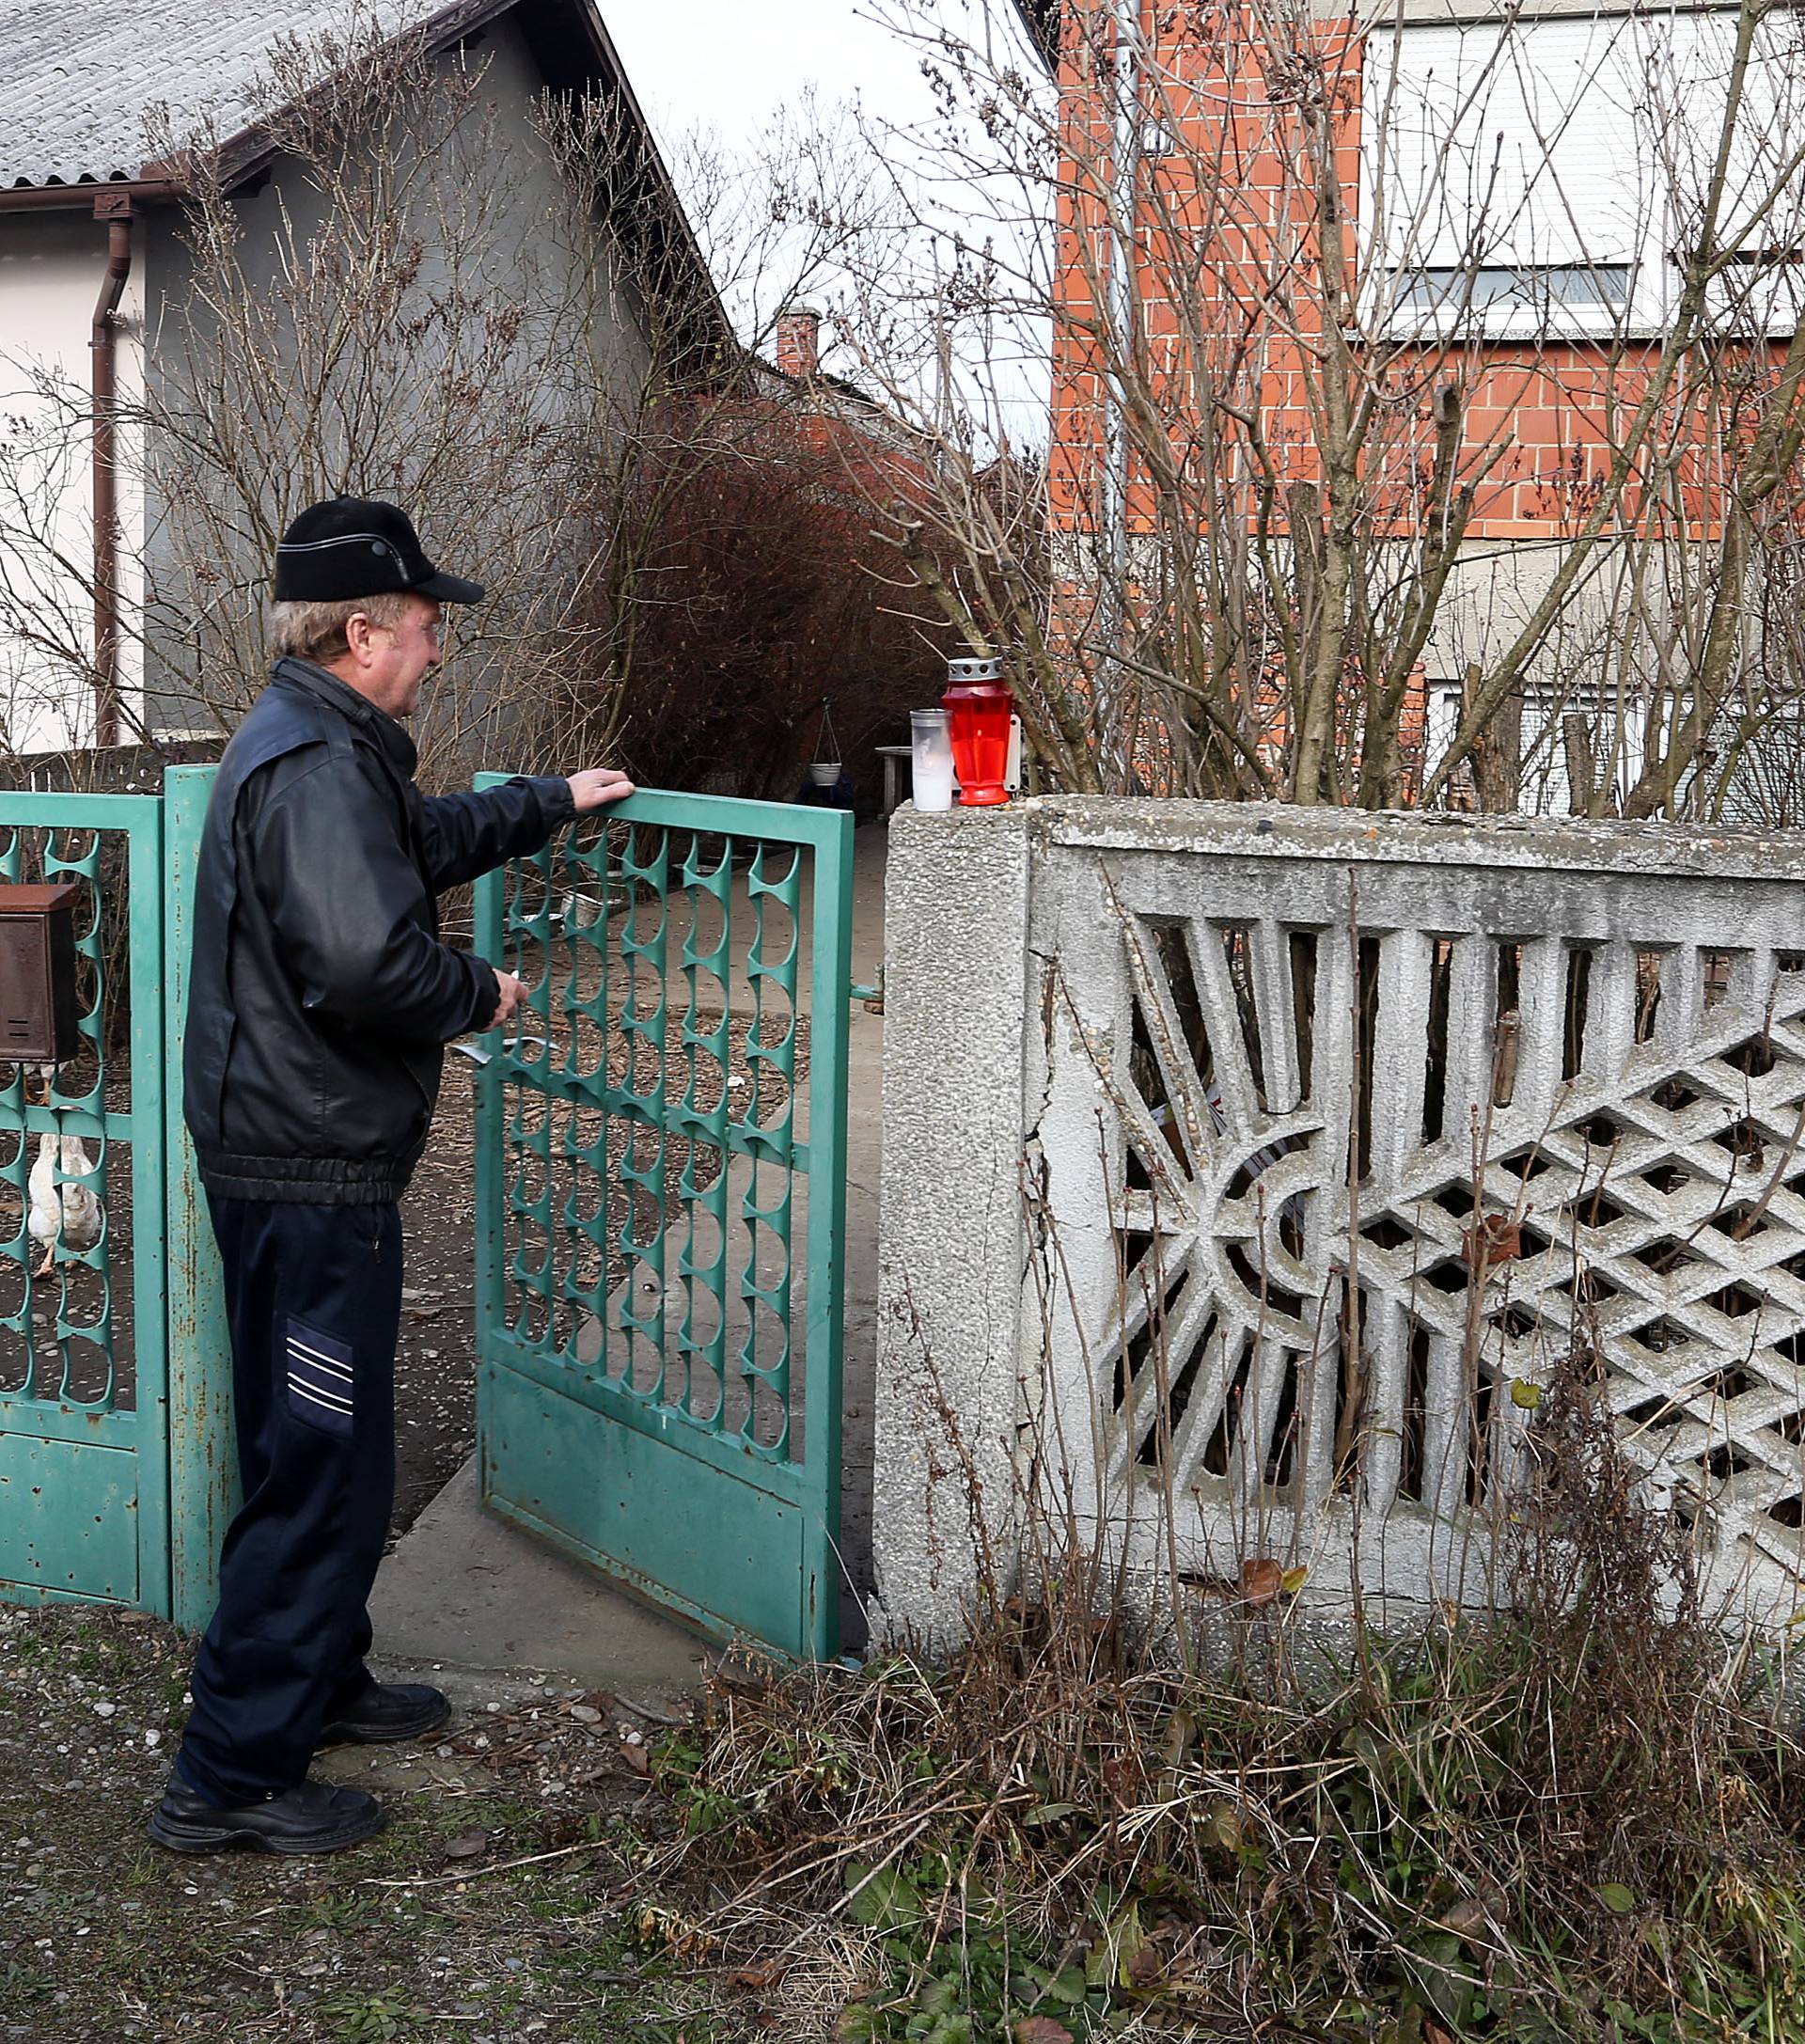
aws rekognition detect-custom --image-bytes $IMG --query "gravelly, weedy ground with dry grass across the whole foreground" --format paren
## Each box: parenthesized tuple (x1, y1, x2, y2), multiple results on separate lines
(0, 1332, 1805, 2044)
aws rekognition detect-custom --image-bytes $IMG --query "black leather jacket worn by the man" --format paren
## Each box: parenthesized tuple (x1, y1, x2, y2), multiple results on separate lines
(182, 660, 574, 1206)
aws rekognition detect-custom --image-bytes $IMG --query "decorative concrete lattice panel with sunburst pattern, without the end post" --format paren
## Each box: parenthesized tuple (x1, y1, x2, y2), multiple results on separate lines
(1032, 806, 1805, 1614)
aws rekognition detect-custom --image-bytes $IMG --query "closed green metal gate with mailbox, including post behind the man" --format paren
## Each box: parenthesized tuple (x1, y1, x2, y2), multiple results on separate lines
(0, 766, 235, 1625)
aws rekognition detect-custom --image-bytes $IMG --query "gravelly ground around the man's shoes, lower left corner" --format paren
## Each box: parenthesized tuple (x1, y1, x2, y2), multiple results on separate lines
(0, 1607, 771, 2044)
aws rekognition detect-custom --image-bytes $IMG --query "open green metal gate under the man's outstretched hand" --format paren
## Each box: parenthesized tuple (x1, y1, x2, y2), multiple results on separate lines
(477, 777, 853, 1656)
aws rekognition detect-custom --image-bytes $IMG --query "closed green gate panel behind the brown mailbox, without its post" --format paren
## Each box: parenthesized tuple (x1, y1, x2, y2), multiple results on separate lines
(0, 794, 169, 1611)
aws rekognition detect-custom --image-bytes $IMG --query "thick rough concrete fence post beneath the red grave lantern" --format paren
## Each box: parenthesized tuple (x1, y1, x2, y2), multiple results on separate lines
(871, 803, 1039, 1643)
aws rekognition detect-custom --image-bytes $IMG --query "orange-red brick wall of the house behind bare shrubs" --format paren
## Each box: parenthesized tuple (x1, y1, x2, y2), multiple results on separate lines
(1051, 0, 1774, 540)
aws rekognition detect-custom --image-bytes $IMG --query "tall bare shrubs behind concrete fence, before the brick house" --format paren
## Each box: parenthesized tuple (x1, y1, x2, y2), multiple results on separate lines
(851, 0, 1805, 815)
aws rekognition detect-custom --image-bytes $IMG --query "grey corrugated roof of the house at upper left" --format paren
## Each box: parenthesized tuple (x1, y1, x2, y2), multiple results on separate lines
(0, 0, 446, 186)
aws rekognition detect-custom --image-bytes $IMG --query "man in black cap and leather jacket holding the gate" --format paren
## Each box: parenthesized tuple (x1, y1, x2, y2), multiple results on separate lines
(151, 496, 632, 1854)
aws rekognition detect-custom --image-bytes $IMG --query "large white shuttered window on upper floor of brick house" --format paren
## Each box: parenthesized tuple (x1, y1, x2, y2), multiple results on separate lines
(1359, 10, 1805, 339)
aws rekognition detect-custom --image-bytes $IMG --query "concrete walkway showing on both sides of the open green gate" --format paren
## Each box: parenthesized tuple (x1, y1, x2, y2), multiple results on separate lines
(370, 824, 887, 1703)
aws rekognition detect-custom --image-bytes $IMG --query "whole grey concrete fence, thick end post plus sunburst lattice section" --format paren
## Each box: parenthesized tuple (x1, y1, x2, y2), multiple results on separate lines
(875, 799, 1805, 1637)
